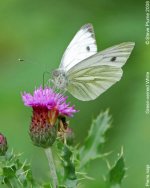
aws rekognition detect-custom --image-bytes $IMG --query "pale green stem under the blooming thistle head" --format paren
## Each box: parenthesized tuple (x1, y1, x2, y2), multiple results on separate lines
(45, 148, 58, 188)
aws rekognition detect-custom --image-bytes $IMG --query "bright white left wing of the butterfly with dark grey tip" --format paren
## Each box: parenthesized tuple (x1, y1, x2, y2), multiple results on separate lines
(59, 24, 97, 71)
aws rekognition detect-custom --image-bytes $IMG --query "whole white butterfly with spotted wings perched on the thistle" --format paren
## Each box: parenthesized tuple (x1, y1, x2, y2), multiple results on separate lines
(52, 24, 134, 101)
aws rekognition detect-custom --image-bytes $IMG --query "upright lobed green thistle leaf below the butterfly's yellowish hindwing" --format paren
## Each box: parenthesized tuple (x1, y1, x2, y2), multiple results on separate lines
(80, 111, 111, 168)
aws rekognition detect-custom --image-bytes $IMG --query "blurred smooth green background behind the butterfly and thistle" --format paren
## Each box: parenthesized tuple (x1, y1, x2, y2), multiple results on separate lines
(0, 0, 150, 188)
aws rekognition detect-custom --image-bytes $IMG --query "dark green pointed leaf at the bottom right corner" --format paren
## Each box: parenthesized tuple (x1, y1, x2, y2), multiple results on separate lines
(108, 151, 126, 188)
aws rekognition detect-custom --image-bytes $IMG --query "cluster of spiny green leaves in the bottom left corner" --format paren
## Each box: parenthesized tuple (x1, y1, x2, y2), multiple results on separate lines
(0, 152, 34, 188)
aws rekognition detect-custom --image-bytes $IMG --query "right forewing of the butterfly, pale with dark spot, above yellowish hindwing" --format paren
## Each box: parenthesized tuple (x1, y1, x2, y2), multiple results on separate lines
(68, 42, 134, 74)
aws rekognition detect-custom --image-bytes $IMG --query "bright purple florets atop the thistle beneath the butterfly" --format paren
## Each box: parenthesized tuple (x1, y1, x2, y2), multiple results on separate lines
(22, 87, 77, 116)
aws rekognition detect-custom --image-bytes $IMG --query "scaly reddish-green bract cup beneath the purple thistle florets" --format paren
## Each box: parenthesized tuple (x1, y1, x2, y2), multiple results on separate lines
(29, 107, 58, 148)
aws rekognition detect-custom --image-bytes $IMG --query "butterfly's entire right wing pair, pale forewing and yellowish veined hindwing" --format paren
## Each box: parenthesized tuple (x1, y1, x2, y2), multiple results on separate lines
(67, 42, 134, 101)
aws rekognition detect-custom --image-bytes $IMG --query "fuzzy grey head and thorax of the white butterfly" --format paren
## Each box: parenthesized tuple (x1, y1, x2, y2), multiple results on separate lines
(52, 69, 67, 90)
